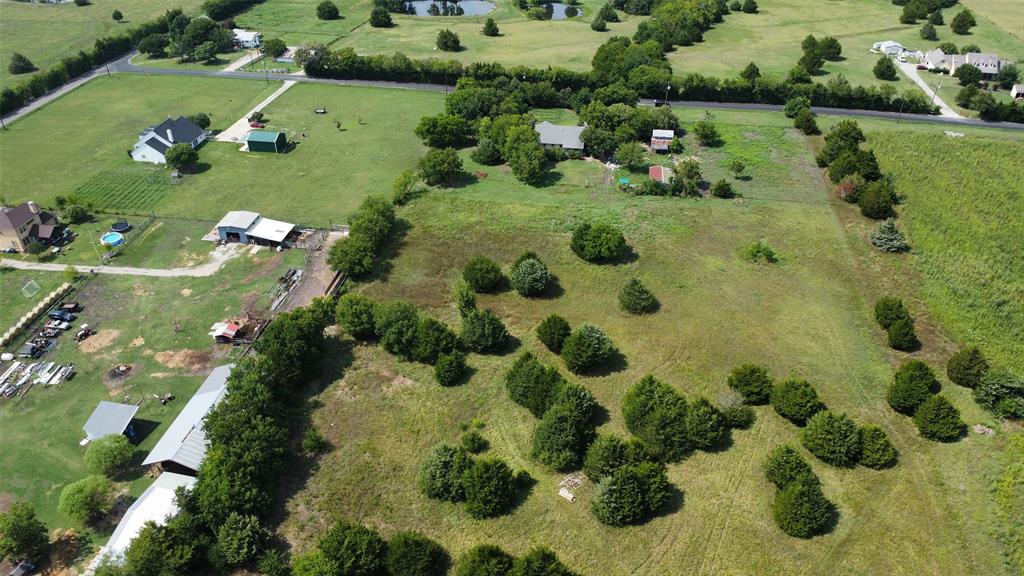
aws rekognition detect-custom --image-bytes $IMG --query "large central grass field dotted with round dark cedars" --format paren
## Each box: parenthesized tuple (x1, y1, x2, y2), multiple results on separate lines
(281, 115, 1010, 576)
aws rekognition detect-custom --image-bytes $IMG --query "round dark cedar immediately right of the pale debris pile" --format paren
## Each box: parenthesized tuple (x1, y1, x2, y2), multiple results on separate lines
(591, 462, 669, 526)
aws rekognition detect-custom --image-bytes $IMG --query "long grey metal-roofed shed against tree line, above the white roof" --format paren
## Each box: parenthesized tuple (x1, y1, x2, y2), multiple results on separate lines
(142, 364, 234, 471)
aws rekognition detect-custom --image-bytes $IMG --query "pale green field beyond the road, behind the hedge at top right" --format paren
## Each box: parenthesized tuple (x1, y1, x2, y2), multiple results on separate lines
(669, 0, 1024, 91)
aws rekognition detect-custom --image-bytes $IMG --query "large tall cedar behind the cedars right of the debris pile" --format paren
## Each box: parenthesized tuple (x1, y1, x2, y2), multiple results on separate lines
(623, 375, 693, 461)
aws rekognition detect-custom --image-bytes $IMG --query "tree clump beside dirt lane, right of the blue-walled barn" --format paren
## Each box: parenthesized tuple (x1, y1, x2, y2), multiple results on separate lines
(327, 196, 395, 278)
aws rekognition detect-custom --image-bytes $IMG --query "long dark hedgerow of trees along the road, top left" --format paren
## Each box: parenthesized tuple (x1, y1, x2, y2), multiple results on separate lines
(0, 8, 181, 114)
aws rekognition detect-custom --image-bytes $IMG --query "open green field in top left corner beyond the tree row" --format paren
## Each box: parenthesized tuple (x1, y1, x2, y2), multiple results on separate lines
(0, 0, 202, 88)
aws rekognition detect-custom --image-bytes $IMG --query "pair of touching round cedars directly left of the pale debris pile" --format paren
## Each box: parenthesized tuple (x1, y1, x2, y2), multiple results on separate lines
(419, 444, 529, 520)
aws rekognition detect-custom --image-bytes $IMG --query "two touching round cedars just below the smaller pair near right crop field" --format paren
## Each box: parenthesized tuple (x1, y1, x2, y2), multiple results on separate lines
(886, 360, 965, 442)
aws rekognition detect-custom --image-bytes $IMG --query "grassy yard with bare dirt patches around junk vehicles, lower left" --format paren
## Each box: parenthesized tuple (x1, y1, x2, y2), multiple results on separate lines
(0, 250, 302, 537)
